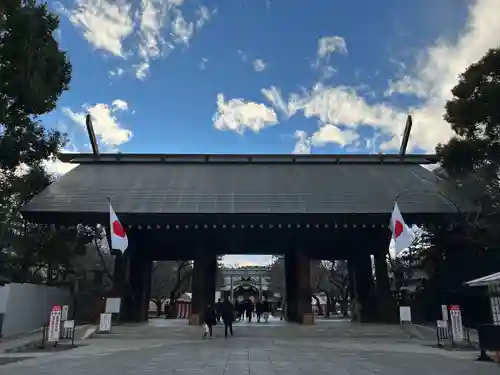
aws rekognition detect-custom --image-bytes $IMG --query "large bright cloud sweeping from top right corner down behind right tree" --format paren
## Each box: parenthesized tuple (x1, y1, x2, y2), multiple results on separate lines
(382, 0, 500, 151)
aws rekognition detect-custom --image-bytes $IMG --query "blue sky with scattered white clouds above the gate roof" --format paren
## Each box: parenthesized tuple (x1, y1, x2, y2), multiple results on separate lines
(43, 0, 500, 263)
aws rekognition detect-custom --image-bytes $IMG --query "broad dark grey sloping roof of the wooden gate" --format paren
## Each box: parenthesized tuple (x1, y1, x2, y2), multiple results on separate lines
(23, 163, 468, 214)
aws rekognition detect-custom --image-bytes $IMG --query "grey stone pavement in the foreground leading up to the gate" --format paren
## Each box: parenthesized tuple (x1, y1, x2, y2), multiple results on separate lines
(0, 320, 500, 375)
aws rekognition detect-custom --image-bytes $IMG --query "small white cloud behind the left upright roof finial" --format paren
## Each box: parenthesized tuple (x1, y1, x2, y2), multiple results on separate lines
(63, 103, 132, 151)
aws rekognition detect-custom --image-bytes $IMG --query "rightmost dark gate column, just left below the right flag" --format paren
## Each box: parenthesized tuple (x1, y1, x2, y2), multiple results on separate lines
(374, 250, 398, 323)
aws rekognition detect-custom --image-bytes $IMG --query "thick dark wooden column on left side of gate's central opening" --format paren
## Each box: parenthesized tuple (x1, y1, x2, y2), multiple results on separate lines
(190, 247, 217, 324)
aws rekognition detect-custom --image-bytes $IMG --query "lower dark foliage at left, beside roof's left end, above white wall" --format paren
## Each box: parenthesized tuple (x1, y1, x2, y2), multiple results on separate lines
(0, 166, 93, 282)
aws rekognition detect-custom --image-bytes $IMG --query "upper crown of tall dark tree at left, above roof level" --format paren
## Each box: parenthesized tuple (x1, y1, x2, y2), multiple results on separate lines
(0, 0, 71, 172)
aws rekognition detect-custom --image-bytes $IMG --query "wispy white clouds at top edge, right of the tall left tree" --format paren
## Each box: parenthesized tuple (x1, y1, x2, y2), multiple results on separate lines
(60, 0, 215, 79)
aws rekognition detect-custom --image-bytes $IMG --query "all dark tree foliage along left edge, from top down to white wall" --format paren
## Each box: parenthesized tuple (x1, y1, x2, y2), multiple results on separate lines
(0, 0, 73, 282)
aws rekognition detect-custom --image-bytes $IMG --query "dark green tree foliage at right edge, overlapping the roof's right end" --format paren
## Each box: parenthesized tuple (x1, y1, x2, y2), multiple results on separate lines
(437, 49, 500, 247)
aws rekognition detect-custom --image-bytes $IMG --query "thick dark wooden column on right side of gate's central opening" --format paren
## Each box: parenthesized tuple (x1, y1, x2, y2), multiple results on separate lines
(285, 249, 312, 322)
